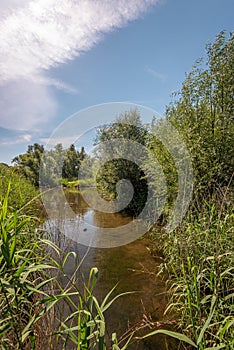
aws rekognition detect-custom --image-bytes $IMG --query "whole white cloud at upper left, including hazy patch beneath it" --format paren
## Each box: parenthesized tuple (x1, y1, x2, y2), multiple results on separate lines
(0, 0, 160, 129)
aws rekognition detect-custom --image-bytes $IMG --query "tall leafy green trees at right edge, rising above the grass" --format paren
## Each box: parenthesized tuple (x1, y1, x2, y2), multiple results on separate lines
(167, 32, 234, 191)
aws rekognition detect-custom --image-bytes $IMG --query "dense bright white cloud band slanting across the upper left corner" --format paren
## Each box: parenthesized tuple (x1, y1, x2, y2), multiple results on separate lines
(0, 0, 158, 81)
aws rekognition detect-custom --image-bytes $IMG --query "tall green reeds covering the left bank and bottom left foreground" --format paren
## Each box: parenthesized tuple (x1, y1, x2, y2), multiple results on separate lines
(0, 179, 132, 350)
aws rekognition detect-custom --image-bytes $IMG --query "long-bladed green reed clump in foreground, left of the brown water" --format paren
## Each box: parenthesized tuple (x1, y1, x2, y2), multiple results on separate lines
(51, 264, 132, 350)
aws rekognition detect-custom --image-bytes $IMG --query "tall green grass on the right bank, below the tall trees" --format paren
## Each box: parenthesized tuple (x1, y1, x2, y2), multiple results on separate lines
(147, 191, 234, 350)
